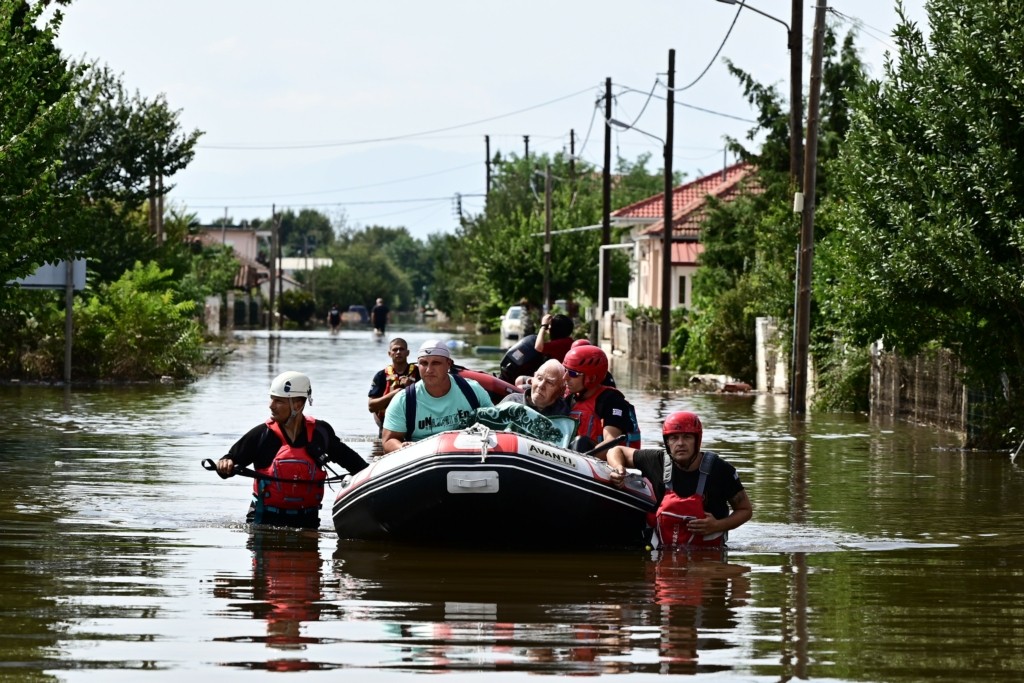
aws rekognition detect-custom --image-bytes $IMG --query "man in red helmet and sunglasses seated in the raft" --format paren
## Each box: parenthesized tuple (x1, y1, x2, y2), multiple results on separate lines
(562, 344, 640, 451)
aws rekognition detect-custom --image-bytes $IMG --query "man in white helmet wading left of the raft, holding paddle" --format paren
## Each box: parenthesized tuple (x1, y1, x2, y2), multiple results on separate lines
(217, 371, 367, 528)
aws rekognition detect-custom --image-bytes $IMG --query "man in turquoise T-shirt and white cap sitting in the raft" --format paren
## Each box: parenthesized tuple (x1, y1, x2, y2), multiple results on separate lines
(381, 339, 494, 453)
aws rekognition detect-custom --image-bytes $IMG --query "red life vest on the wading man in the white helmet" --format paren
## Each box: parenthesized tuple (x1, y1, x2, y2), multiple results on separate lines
(253, 417, 327, 510)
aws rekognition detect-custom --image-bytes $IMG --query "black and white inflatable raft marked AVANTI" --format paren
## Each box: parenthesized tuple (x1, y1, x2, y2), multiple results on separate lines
(334, 417, 655, 547)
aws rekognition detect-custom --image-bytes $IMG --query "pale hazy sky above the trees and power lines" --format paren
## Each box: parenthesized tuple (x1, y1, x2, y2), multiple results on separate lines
(51, 0, 926, 238)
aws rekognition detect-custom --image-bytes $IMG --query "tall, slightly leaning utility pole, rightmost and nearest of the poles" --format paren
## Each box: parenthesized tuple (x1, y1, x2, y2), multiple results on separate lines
(790, 0, 827, 415)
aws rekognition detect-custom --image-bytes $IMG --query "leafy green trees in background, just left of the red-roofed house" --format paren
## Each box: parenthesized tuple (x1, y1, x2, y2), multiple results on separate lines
(432, 154, 663, 323)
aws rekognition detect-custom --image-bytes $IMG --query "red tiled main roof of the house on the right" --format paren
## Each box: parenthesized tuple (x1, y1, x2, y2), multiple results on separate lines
(611, 162, 754, 240)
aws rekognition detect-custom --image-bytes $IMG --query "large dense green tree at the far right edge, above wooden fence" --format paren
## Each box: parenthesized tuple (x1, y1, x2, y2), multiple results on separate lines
(827, 0, 1024, 441)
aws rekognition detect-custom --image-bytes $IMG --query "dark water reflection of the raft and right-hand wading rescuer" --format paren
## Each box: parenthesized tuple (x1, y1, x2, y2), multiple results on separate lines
(334, 542, 750, 674)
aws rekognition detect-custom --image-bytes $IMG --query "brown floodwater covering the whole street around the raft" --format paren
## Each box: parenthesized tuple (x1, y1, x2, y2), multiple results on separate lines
(0, 330, 1024, 683)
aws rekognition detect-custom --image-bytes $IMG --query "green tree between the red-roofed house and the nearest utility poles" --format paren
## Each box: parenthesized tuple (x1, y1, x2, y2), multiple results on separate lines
(692, 28, 864, 382)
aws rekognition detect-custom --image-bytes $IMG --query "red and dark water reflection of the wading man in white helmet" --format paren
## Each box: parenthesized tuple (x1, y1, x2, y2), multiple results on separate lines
(214, 527, 323, 671)
